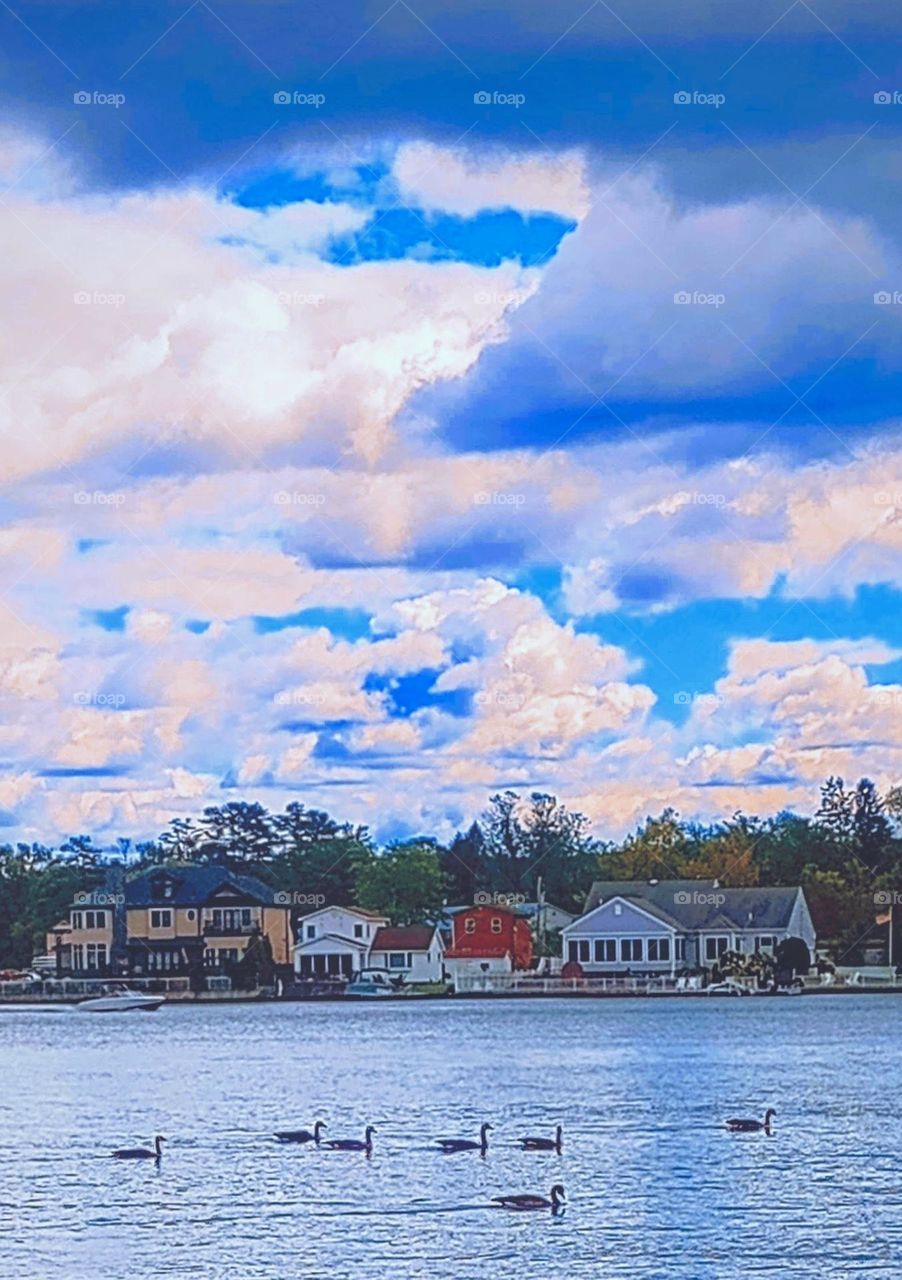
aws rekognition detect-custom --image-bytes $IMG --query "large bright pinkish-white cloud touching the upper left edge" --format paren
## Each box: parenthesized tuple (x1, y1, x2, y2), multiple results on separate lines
(0, 145, 532, 476)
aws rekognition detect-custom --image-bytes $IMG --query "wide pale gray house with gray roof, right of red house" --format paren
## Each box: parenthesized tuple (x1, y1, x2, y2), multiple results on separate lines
(563, 881, 816, 974)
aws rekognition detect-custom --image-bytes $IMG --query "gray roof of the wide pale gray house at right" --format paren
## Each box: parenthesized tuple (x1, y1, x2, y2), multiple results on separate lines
(586, 879, 800, 929)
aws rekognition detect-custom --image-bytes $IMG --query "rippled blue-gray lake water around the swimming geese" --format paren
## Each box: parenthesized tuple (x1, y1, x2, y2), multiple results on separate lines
(0, 996, 902, 1280)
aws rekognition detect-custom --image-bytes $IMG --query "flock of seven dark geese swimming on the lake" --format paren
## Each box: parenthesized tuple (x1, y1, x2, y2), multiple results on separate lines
(111, 1107, 777, 1213)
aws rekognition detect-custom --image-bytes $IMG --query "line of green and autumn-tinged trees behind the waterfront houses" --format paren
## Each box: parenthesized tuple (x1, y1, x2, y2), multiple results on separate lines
(0, 777, 902, 969)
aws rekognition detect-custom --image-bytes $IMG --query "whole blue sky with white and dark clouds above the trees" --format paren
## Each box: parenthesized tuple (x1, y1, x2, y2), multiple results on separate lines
(0, 0, 902, 844)
